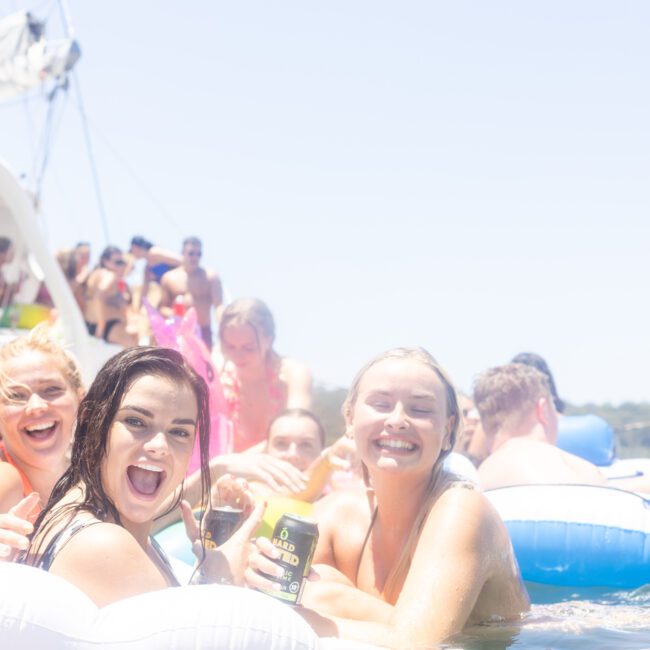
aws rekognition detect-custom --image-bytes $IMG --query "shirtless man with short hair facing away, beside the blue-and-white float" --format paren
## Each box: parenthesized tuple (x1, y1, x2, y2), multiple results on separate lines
(474, 363, 650, 492)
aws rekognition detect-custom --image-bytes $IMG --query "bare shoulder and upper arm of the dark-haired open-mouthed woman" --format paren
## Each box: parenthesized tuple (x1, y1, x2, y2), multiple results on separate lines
(50, 523, 169, 607)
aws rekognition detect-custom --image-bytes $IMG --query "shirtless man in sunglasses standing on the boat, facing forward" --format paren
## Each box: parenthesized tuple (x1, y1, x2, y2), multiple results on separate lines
(160, 237, 223, 349)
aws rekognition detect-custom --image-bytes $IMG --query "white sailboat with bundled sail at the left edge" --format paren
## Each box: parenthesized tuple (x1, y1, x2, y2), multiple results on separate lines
(0, 11, 120, 381)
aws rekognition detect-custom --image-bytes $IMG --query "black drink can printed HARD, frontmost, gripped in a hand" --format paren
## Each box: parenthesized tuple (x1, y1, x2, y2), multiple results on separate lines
(266, 514, 318, 605)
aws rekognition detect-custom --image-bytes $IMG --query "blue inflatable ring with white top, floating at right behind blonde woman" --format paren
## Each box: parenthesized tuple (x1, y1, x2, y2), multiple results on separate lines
(486, 485, 650, 588)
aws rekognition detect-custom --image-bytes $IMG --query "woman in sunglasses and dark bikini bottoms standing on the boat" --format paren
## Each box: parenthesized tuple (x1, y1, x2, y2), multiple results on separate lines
(84, 246, 137, 347)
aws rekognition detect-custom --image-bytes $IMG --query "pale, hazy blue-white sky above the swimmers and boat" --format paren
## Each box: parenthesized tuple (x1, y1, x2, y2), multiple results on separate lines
(0, 0, 650, 404)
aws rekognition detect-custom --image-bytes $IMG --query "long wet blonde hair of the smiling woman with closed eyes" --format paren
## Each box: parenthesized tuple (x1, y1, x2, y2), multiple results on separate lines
(343, 348, 463, 603)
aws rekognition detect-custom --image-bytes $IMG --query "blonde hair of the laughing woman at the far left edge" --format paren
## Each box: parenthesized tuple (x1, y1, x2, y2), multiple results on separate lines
(0, 323, 83, 400)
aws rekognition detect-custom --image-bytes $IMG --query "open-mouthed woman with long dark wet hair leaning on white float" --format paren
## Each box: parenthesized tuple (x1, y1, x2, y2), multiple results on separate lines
(22, 347, 259, 606)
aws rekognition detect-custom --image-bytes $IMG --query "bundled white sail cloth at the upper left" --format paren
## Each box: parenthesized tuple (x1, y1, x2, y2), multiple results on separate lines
(0, 11, 81, 101)
